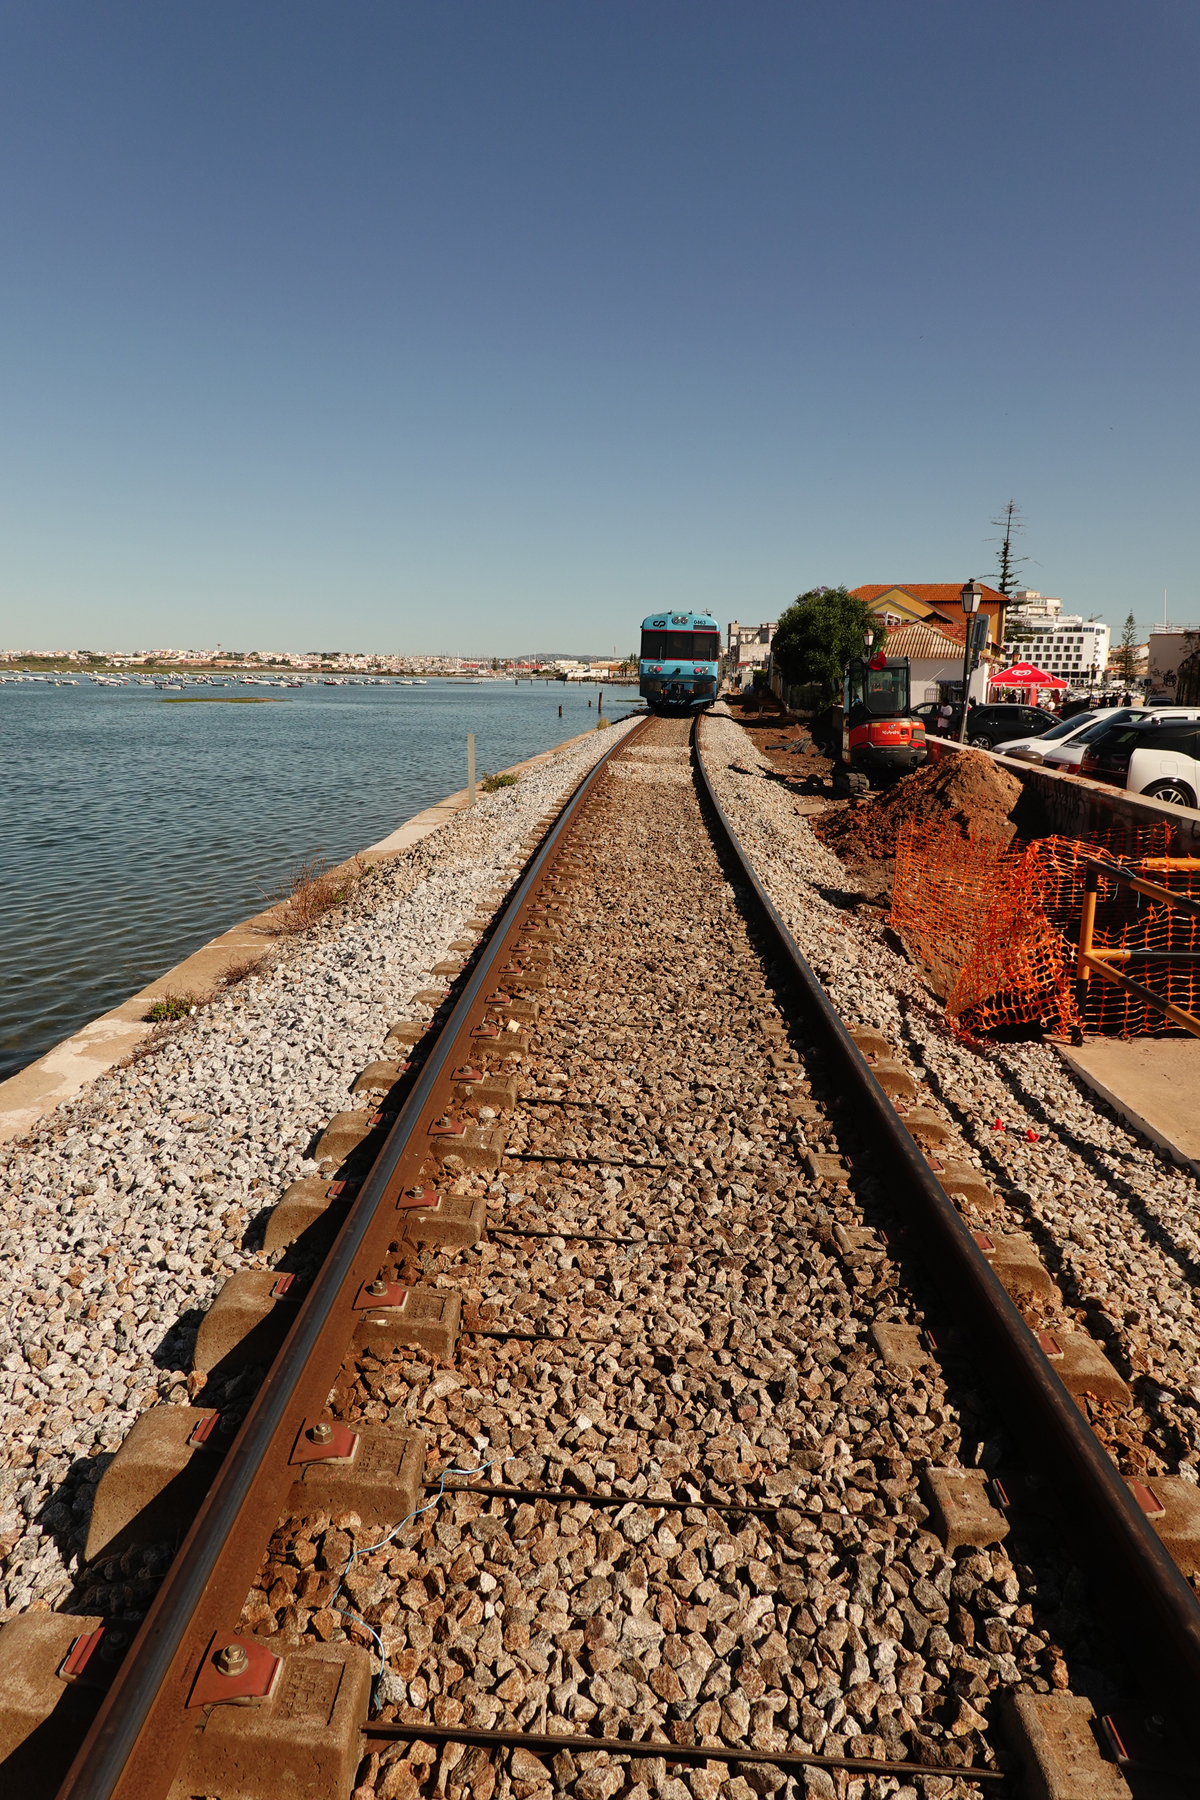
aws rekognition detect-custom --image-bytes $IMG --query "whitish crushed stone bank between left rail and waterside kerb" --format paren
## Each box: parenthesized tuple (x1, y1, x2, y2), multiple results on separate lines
(0, 722, 633, 1622)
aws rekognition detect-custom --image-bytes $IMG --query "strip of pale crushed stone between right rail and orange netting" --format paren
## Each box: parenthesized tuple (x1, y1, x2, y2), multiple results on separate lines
(702, 711, 1200, 1481)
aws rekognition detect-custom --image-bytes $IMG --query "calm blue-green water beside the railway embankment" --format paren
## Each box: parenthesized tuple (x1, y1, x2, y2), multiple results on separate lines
(0, 682, 637, 1078)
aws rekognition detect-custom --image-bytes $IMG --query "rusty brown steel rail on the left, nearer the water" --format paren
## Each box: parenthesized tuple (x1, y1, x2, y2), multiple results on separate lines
(58, 722, 648, 1800)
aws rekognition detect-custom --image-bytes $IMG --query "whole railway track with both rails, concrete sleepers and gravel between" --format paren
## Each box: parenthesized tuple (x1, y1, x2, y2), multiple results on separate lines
(0, 720, 1200, 1800)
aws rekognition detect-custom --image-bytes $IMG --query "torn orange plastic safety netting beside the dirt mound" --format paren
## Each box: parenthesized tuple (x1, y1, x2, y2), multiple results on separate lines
(891, 824, 1200, 1037)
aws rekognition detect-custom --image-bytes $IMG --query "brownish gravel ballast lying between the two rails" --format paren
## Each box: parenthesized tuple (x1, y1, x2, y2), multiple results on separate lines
(232, 724, 1123, 1800)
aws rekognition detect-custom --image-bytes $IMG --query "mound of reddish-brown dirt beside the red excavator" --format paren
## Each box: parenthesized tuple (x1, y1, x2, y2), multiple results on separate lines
(811, 749, 1024, 860)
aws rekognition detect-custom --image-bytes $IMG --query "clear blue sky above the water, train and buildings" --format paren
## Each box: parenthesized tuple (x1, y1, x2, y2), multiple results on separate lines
(0, 0, 1200, 655)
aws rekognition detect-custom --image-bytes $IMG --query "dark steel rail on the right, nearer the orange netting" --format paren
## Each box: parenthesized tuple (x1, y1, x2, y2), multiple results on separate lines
(693, 720, 1200, 1717)
